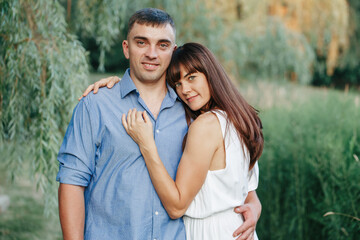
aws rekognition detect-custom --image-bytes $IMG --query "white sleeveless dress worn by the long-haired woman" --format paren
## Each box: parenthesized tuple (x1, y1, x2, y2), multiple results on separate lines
(183, 111, 259, 240)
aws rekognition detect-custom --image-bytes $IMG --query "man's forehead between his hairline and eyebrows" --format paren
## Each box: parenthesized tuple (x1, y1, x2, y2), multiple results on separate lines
(128, 23, 175, 41)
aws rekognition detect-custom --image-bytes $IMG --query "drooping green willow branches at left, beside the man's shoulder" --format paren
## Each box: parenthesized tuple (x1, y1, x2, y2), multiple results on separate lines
(0, 0, 88, 214)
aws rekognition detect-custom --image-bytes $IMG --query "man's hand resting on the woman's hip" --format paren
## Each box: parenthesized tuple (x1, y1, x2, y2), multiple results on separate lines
(233, 191, 261, 240)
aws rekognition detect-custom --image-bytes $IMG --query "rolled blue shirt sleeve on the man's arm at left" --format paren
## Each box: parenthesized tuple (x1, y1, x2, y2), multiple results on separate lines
(56, 100, 95, 187)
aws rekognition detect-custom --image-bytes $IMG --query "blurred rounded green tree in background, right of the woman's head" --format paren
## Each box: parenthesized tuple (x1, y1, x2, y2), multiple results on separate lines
(228, 17, 314, 84)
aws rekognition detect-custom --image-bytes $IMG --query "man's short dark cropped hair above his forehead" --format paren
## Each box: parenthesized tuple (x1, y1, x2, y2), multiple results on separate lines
(127, 8, 175, 35)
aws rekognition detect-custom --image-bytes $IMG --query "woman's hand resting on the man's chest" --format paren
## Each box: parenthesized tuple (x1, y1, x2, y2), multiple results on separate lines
(122, 108, 155, 150)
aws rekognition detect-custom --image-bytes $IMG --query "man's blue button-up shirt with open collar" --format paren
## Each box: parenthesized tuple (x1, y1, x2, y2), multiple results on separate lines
(57, 70, 187, 240)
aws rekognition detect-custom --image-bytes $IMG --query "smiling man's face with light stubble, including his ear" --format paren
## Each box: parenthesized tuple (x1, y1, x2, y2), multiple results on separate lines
(123, 23, 176, 84)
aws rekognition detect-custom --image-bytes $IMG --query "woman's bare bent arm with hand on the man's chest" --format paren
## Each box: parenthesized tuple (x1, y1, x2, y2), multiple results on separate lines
(123, 110, 223, 219)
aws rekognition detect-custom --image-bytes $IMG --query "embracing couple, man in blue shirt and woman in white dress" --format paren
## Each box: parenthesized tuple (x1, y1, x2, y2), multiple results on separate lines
(57, 8, 263, 240)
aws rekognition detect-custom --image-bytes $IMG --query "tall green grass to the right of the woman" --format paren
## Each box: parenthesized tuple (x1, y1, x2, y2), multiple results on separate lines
(258, 92, 360, 240)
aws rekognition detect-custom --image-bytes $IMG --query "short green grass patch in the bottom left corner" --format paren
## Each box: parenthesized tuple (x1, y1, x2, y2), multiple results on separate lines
(0, 162, 62, 240)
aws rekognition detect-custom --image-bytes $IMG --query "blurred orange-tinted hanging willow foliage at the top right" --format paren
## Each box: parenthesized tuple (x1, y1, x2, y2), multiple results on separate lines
(241, 0, 350, 83)
